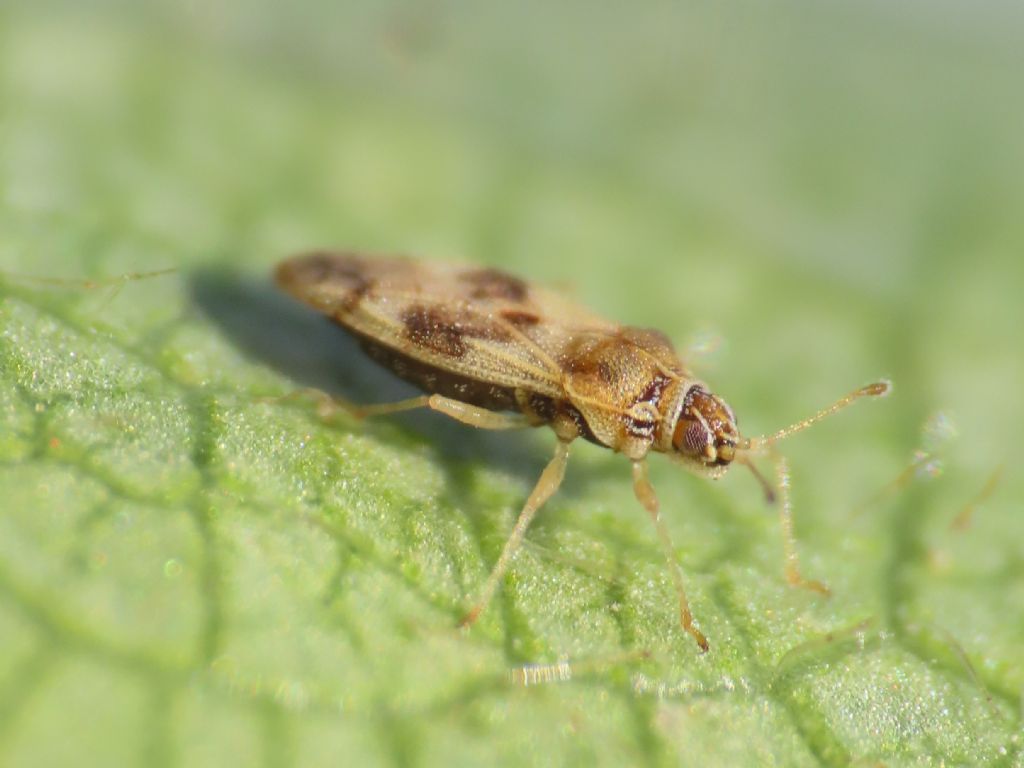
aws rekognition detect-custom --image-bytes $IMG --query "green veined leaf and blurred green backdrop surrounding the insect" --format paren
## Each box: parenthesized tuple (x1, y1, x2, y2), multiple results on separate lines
(0, 0, 1024, 767)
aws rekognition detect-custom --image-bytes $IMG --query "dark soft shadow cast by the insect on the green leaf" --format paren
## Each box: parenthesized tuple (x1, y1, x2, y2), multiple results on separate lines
(187, 268, 606, 486)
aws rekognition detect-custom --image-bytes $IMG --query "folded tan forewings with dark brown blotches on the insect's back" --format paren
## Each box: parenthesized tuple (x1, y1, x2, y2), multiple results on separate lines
(276, 253, 614, 397)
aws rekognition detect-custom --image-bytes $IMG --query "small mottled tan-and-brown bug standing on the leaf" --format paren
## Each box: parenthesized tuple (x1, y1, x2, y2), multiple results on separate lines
(275, 252, 890, 651)
